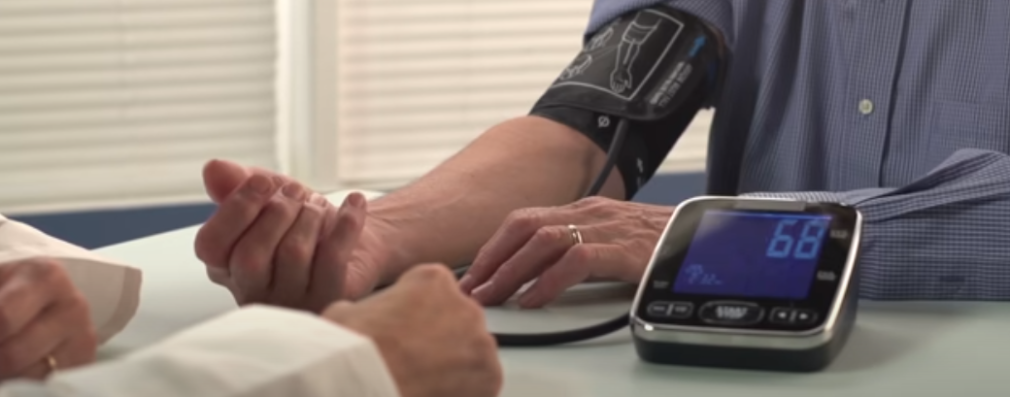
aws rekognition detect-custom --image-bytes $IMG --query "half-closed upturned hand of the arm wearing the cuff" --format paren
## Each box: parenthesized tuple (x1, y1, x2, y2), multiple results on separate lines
(196, 161, 386, 313)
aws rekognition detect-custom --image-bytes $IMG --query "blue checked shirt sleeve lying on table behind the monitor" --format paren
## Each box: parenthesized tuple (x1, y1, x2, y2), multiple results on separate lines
(747, 150, 1010, 300)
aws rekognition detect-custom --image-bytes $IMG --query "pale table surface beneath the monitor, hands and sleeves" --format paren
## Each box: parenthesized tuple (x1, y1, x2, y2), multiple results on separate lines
(100, 189, 1010, 397)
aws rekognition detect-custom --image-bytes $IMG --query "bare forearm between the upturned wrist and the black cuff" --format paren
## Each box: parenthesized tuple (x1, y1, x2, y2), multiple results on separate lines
(370, 116, 624, 275)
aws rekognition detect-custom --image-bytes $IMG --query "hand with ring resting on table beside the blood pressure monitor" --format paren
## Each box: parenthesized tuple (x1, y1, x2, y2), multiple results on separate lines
(461, 197, 674, 308)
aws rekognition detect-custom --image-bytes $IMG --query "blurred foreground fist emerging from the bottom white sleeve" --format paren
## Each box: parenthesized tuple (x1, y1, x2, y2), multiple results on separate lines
(323, 265, 502, 397)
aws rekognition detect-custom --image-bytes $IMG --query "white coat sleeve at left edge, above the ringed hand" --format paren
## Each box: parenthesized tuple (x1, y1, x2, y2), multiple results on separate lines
(0, 210, 141, 342)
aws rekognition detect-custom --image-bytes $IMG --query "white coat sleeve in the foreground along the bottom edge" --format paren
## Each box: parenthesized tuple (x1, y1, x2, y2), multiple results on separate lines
(0, 306, 399, 397)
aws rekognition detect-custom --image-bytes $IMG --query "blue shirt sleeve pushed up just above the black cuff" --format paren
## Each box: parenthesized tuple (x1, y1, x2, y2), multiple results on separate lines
(586, 0, 734, 44)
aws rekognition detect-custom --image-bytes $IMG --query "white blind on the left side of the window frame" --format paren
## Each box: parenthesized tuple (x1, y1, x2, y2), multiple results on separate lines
(0, 0, 277, 212)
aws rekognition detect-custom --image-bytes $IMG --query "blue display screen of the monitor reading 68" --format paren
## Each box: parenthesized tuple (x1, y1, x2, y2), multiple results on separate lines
(674, 210, 831, 300)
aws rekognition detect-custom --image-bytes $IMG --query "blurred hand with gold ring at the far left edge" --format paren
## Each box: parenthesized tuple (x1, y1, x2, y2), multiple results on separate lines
(0, 259, 98, 382)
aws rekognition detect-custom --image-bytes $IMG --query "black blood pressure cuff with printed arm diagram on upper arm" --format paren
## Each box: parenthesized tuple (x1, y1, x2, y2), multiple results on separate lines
(530, 6, 723, 198)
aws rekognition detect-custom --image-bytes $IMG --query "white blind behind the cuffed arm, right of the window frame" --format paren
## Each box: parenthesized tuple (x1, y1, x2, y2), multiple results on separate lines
(335, 0, 710, 188)
